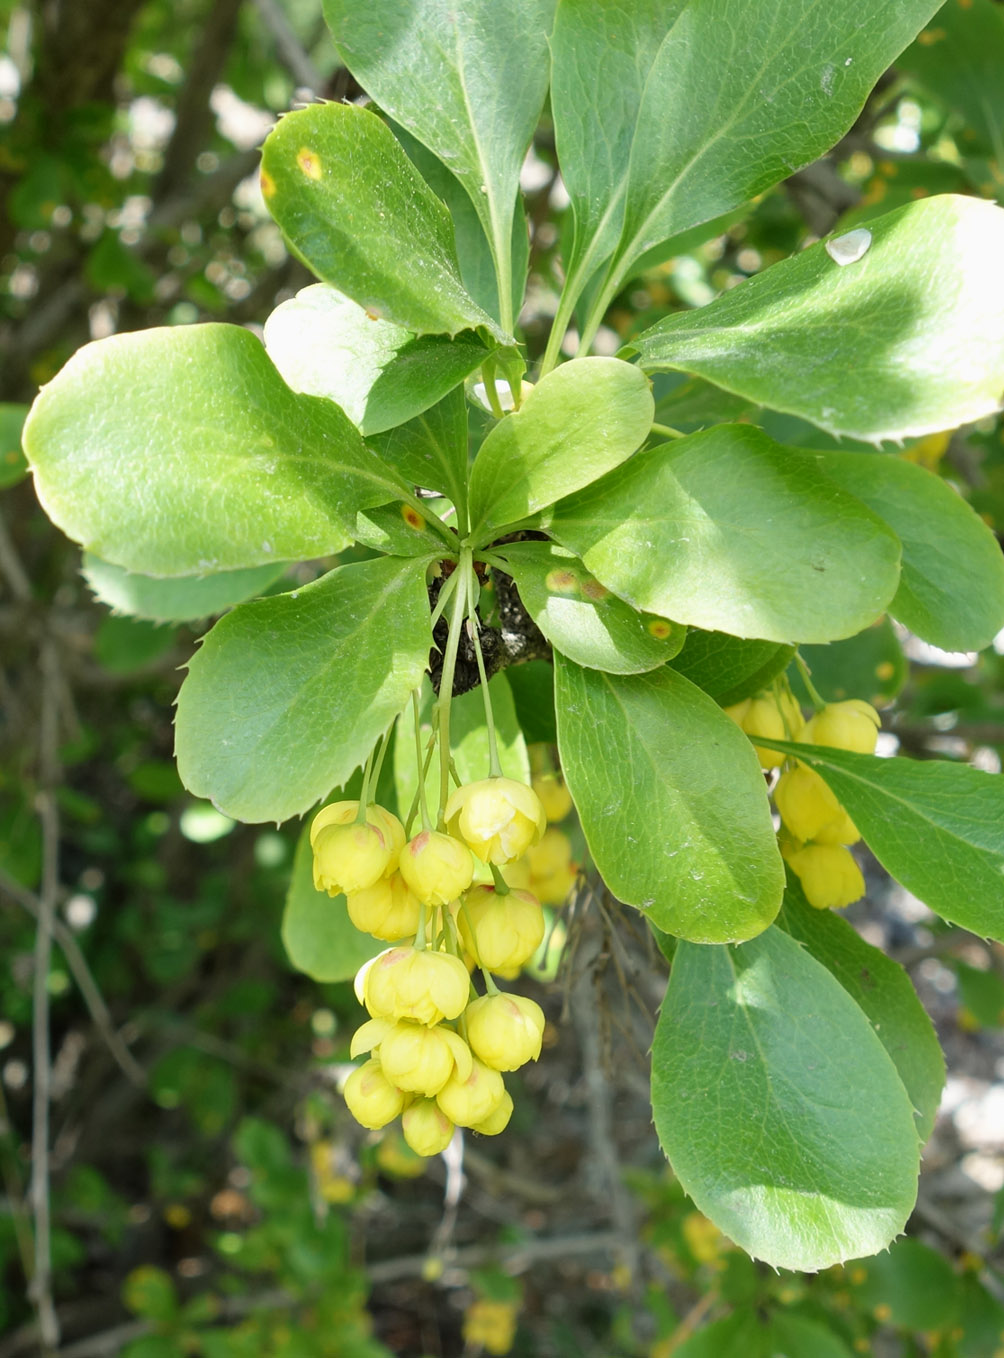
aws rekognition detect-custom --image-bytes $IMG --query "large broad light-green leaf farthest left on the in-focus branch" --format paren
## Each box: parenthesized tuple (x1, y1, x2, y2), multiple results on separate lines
(24, 325, 413, 576)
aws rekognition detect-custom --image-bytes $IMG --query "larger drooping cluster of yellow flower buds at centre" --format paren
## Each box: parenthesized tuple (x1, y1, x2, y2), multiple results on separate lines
(311, 778, 546, 1156)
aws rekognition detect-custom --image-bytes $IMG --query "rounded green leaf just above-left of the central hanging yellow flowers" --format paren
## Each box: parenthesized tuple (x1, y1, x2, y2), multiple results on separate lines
(175, 558, 431, 820)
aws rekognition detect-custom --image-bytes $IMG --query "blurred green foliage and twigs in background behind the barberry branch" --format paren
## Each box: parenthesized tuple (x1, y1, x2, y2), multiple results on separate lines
(0, 0, 1004, 1358)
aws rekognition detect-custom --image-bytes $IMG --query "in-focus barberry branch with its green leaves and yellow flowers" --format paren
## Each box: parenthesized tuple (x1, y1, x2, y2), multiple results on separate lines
(17, 0, 1004, 1270)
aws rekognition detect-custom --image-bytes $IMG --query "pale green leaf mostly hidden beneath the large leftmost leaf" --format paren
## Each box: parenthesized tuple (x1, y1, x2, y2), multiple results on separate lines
(80, 551, 287, 622)
